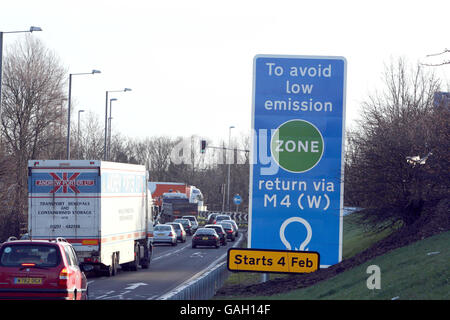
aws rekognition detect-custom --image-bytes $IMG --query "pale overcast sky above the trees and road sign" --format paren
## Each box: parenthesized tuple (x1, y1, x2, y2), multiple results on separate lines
(0, 0, 450, 141)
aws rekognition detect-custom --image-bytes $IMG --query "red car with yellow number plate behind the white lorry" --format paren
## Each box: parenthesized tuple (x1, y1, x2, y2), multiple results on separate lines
(0, 238, 92, 300)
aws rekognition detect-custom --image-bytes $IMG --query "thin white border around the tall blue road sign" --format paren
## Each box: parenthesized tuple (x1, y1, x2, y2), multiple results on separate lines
(247, 54, 347, 268)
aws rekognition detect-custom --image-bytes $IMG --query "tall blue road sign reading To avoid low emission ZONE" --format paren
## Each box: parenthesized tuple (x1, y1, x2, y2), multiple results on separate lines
(249, 55, 346, 267)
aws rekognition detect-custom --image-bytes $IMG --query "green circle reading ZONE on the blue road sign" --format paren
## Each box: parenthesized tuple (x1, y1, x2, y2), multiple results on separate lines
(270, 119, 324, 173)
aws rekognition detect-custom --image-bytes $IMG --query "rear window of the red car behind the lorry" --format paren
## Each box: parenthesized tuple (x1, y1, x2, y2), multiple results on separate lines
(0, 244, 61, 268)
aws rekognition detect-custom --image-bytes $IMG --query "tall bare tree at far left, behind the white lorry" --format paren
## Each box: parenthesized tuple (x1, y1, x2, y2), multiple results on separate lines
(0, 36, 66, 238)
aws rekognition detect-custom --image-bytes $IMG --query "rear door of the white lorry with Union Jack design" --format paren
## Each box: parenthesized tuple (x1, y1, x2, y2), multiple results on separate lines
(28, 166, 100, 253)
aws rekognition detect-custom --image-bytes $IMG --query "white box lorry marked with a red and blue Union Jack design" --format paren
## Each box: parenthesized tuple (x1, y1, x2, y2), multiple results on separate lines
(28, 160, 153, 276)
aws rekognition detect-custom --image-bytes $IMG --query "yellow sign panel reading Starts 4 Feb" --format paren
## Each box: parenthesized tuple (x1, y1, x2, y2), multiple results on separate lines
(227, 248, 320, 273)
